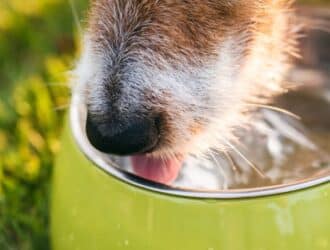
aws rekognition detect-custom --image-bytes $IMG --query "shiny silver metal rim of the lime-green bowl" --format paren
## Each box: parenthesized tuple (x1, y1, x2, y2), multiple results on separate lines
(69, 93, 330, 199)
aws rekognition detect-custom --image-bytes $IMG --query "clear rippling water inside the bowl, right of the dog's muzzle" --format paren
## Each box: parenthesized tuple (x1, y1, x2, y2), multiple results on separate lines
(111, 27, 330, 191)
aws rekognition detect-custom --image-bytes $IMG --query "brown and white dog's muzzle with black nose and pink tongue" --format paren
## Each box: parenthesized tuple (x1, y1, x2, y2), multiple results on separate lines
(73, 0, 324, 188)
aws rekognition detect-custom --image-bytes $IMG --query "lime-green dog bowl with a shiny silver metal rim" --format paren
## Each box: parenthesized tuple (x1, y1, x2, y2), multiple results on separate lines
(51, 95, 330, 250)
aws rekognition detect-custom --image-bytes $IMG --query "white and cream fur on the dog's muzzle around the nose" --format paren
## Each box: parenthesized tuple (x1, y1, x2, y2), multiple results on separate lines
(73, 0, 308, 188)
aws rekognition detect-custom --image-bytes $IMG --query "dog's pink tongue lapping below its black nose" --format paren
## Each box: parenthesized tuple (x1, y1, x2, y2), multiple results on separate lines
(131, 155, 182, 184)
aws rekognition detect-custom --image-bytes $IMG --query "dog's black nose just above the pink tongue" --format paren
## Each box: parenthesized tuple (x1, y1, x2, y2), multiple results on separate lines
(86, 116, 159, 155)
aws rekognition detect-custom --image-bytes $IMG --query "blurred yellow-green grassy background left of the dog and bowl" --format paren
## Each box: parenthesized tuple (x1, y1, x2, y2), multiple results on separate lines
(0, 0, 330, 250)
